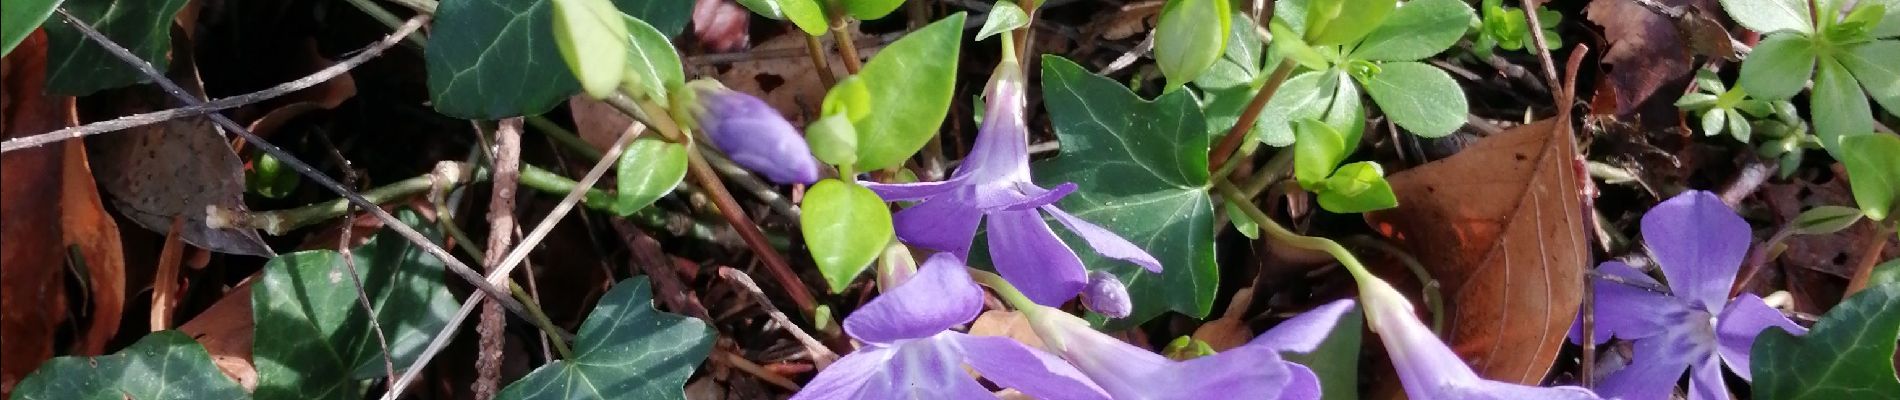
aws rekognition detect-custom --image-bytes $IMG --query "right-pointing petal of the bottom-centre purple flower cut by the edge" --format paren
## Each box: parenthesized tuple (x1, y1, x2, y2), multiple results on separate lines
(944, 332, 1108, 400)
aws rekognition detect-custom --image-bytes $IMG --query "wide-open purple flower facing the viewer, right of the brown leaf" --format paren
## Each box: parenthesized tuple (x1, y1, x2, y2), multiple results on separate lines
(1571, 191, 1807, 400)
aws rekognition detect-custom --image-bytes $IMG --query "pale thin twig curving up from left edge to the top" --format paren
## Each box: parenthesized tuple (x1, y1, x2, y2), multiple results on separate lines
(0, 17, 428, 154)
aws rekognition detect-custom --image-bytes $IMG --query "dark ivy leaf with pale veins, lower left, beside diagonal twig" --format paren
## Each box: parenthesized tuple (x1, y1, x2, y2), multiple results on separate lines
(251, 210, 456, 400)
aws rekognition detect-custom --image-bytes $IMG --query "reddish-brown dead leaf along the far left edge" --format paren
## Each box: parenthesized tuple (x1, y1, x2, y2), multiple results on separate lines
(0, 32, 72, 396)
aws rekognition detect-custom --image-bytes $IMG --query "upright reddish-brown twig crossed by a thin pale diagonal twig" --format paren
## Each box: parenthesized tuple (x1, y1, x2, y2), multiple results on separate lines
(473, 118, 521, 400)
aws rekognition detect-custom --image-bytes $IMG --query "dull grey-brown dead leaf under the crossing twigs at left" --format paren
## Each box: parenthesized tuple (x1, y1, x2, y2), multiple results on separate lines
(93, 36, 276, 256)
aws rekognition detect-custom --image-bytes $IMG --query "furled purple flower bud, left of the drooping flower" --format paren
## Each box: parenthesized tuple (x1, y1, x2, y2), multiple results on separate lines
(694, 87, 819, 184)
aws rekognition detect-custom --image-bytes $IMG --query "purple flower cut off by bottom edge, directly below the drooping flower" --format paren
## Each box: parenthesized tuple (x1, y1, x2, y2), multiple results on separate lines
(792, 254, 1108, 400)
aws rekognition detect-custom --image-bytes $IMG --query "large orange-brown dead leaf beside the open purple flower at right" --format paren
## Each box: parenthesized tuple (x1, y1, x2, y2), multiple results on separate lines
(1366, 118, 1590, 385)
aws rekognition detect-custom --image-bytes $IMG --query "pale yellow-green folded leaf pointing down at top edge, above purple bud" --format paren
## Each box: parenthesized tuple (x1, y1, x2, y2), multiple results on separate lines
(553, 0, 638, 99)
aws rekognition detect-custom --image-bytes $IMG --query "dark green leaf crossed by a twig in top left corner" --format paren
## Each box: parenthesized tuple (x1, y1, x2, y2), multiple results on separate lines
(42, 0, 184, 97)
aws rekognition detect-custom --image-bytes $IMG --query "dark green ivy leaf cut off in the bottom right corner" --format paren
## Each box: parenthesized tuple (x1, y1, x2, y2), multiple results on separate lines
(1748, 284, 1900, 400)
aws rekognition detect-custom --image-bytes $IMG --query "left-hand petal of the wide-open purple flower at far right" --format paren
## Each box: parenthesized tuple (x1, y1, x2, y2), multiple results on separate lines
(1571, 262, 1691, 343)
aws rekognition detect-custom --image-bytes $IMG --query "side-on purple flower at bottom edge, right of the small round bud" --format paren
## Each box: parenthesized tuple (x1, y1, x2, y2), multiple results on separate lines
(1022, 301, 1351, 400)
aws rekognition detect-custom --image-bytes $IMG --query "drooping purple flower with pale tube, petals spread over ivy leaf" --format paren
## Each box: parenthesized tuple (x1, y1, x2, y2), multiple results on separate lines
(866, 63, 1161, 305)
